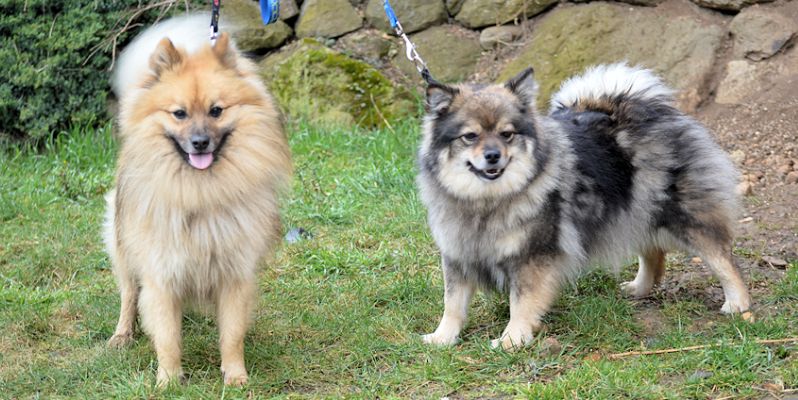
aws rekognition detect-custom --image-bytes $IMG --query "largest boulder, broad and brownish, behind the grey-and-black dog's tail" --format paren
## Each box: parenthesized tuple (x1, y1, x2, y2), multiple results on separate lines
(499, 0, 725, 111)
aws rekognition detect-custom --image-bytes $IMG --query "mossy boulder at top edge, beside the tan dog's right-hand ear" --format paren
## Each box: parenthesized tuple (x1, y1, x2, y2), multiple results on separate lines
(223, 0, 293, 52)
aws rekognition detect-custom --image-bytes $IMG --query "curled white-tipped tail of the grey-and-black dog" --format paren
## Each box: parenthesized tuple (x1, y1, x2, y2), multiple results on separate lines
(550, 63, 673, 123)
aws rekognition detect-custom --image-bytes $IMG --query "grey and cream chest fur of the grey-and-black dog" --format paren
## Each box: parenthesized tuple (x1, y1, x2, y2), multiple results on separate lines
(419, 173, 567, 290)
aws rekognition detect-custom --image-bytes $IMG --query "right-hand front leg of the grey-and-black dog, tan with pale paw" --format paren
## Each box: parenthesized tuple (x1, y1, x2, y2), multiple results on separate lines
(491, 264, 561, 350)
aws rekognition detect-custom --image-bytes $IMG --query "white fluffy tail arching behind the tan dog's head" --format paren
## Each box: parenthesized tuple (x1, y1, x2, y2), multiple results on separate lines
(111, 14, 211, 98)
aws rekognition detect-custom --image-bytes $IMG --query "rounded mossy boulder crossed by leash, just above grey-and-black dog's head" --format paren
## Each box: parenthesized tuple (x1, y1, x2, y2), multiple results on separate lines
(393, 25, 482, 82)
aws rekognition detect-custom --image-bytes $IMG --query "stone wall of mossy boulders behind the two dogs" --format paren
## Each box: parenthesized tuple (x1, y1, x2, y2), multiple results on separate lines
(221, 0, 798, 126)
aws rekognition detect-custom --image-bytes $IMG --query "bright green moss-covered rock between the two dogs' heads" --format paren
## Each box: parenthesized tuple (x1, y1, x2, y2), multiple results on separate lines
(260, 39, 415, 127)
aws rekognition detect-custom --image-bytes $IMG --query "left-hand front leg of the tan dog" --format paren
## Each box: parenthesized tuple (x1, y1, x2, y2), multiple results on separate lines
(139, 279, 183, 387)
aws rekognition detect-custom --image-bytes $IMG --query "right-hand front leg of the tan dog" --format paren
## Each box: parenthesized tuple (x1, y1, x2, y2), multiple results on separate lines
(217, 278, 257, 386)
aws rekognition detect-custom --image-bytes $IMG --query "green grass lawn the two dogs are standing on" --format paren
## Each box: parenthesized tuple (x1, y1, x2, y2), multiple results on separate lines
(0, 121, 798, 399)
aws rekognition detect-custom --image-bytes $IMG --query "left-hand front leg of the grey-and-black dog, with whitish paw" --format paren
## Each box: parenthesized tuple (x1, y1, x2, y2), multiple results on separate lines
(421, 260, 476, 346)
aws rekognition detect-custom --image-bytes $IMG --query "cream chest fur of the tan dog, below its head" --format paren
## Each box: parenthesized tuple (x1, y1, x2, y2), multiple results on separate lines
(106, 183, 280, 300)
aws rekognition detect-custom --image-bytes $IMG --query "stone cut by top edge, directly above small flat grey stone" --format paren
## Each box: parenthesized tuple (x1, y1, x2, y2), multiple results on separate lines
(455, 0, 557, 28)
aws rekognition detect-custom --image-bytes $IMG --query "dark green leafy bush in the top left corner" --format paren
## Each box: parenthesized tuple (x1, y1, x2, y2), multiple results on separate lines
(0, 0, 192, 142)
